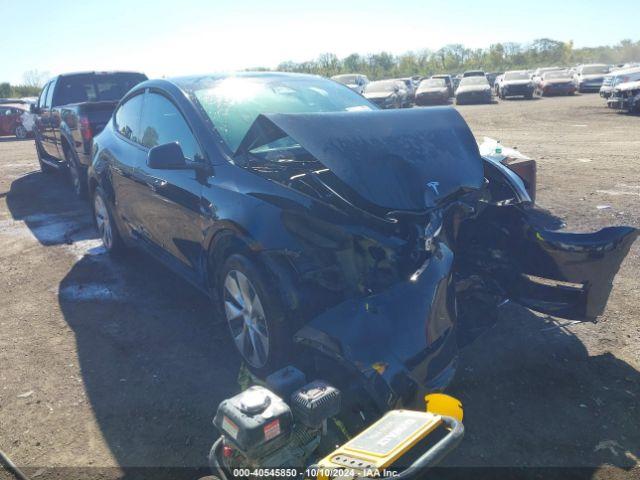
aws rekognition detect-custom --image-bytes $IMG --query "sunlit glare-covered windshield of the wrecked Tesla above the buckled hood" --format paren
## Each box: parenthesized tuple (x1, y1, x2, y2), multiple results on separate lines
(192, 76, 373, 152)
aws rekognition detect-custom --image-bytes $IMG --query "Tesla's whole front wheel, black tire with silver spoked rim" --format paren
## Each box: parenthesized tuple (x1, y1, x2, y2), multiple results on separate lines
(217, 254, 293, 378)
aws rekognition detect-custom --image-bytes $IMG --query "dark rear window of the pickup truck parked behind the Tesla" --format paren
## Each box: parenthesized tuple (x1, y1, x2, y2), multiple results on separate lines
(55, 73, 146, 105)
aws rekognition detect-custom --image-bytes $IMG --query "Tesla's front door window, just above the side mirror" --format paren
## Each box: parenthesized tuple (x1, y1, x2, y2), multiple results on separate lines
(140, 93, 200, 160)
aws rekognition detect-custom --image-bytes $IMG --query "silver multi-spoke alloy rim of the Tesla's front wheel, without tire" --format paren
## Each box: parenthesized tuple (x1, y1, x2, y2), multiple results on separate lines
(224, 270, 269, 368)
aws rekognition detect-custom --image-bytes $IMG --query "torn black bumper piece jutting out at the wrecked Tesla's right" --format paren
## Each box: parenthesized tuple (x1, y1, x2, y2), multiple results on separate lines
(461, 205, 639, 320)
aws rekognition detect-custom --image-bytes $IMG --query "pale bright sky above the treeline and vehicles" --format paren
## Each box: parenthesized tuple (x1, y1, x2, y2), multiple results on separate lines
(0, 0, 640, 84)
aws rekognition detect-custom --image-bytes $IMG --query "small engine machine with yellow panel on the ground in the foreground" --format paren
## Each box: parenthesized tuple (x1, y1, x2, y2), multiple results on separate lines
(209, 367, 464, 480)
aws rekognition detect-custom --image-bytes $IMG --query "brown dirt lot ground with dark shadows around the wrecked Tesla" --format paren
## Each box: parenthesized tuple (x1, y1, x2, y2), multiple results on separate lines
(0, 95, 640, 479)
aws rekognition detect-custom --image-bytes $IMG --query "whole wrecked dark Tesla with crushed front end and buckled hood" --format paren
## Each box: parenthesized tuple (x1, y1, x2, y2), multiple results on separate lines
(90, 73, 637, 406)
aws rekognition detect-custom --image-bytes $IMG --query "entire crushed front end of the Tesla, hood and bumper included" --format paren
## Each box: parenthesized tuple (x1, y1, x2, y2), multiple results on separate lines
(230, 108, 637, 412)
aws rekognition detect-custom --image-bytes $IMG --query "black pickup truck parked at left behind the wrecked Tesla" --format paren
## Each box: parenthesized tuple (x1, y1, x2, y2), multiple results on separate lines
(31, 72, 147, 197)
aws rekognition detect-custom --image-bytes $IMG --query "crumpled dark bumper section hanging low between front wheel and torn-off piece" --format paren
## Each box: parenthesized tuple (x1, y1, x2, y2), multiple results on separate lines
(294, 244, 458, 409)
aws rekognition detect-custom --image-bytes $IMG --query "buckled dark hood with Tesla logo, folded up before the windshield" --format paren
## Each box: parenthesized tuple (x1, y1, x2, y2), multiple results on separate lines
(236, 107, 484, 211)
